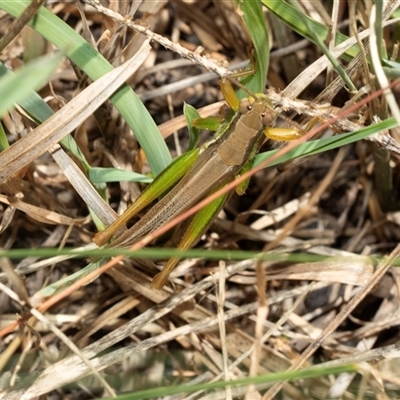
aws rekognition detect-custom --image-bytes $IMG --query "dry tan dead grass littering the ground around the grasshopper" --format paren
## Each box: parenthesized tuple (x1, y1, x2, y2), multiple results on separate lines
(0, 1, 400, 399)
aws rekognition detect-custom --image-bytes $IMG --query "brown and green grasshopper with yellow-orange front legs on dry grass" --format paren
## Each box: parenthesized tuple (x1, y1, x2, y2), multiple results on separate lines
(93, 79, 302, 289)
